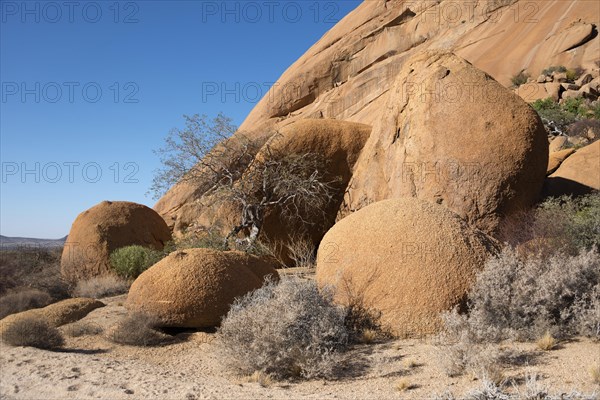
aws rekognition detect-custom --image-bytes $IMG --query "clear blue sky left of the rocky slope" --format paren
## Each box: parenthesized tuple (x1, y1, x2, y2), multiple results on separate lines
(0, 0, 360, 238)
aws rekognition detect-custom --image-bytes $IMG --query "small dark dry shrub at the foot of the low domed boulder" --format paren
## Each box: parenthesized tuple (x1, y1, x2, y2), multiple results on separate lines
(108, 312, 173, 347)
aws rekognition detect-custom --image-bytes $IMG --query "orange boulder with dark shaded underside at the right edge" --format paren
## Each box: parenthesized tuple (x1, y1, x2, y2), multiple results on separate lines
(544, 141, 600, 196)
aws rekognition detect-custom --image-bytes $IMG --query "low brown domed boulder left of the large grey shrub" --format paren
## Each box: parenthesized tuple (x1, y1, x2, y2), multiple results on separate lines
(125, 249, 279, 328)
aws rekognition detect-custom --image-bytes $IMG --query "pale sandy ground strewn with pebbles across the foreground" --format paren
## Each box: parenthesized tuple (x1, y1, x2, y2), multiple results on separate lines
(0, 296, 600, 400)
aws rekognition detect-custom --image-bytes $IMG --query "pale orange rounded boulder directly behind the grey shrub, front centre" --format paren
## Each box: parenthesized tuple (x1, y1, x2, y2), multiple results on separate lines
(316, 198, 496, 337)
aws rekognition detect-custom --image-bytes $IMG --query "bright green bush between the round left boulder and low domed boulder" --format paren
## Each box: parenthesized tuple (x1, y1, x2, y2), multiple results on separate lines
(110, 245, 164, 279)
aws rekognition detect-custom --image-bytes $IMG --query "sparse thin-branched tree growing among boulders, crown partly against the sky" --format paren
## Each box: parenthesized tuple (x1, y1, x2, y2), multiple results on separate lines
(152, 114, 339, 248)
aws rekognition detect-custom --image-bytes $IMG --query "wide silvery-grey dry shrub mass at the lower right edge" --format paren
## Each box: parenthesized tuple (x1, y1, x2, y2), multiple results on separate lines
(454, 247, 600, 342)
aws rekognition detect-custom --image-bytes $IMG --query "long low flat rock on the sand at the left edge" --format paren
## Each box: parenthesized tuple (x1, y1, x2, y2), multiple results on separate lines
(0, 298, 104, 336)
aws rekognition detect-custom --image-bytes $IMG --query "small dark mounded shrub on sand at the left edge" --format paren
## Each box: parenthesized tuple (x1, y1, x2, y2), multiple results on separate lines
(2, 317, 65, 349)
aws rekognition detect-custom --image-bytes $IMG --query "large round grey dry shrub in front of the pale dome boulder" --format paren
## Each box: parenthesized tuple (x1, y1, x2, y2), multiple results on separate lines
(217, 278, 348, 379)
